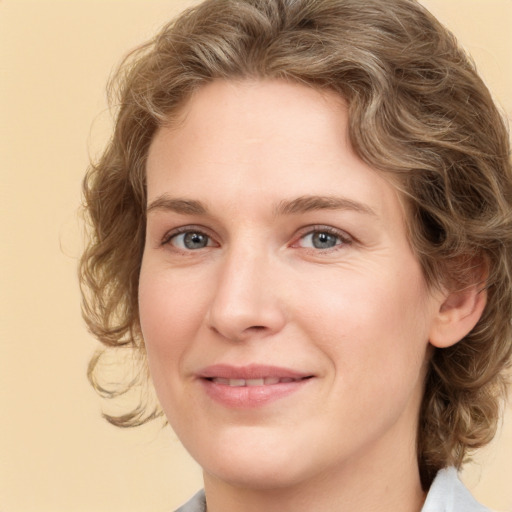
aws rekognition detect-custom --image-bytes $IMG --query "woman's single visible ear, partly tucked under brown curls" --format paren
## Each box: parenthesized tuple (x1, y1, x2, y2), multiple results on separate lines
(429, 284, 487, 348)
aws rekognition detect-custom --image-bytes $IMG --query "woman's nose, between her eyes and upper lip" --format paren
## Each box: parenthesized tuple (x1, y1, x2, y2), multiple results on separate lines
(207, 246, 285, 341)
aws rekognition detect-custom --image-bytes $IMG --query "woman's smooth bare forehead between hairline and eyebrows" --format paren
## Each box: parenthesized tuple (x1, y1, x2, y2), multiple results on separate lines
(147, 81, 406, 224)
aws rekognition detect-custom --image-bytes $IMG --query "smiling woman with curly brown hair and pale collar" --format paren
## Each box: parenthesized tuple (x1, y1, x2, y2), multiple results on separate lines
(81, 0, 512, 512)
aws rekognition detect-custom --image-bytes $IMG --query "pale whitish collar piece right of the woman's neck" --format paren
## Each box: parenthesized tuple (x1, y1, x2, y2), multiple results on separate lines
(421, 468, 491, 512)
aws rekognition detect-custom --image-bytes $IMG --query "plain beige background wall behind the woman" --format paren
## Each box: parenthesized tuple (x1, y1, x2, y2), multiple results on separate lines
(0, 0, 512, 512)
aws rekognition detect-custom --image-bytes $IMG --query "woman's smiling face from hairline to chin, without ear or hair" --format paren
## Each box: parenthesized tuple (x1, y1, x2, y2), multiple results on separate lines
(139, 81, 439, 488)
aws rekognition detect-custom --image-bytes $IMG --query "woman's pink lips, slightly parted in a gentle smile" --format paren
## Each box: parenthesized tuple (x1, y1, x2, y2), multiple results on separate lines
(198, 365, 314, 409)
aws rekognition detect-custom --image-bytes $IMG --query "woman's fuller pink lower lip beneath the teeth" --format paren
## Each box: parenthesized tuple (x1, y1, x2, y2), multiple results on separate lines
(201, 379, 311, 409)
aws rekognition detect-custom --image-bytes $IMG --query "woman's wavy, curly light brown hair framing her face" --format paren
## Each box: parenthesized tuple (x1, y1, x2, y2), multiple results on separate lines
(80, 0, 512, 488)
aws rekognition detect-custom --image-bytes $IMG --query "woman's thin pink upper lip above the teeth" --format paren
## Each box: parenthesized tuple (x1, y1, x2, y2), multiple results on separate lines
(197, 364, 312, 380)
